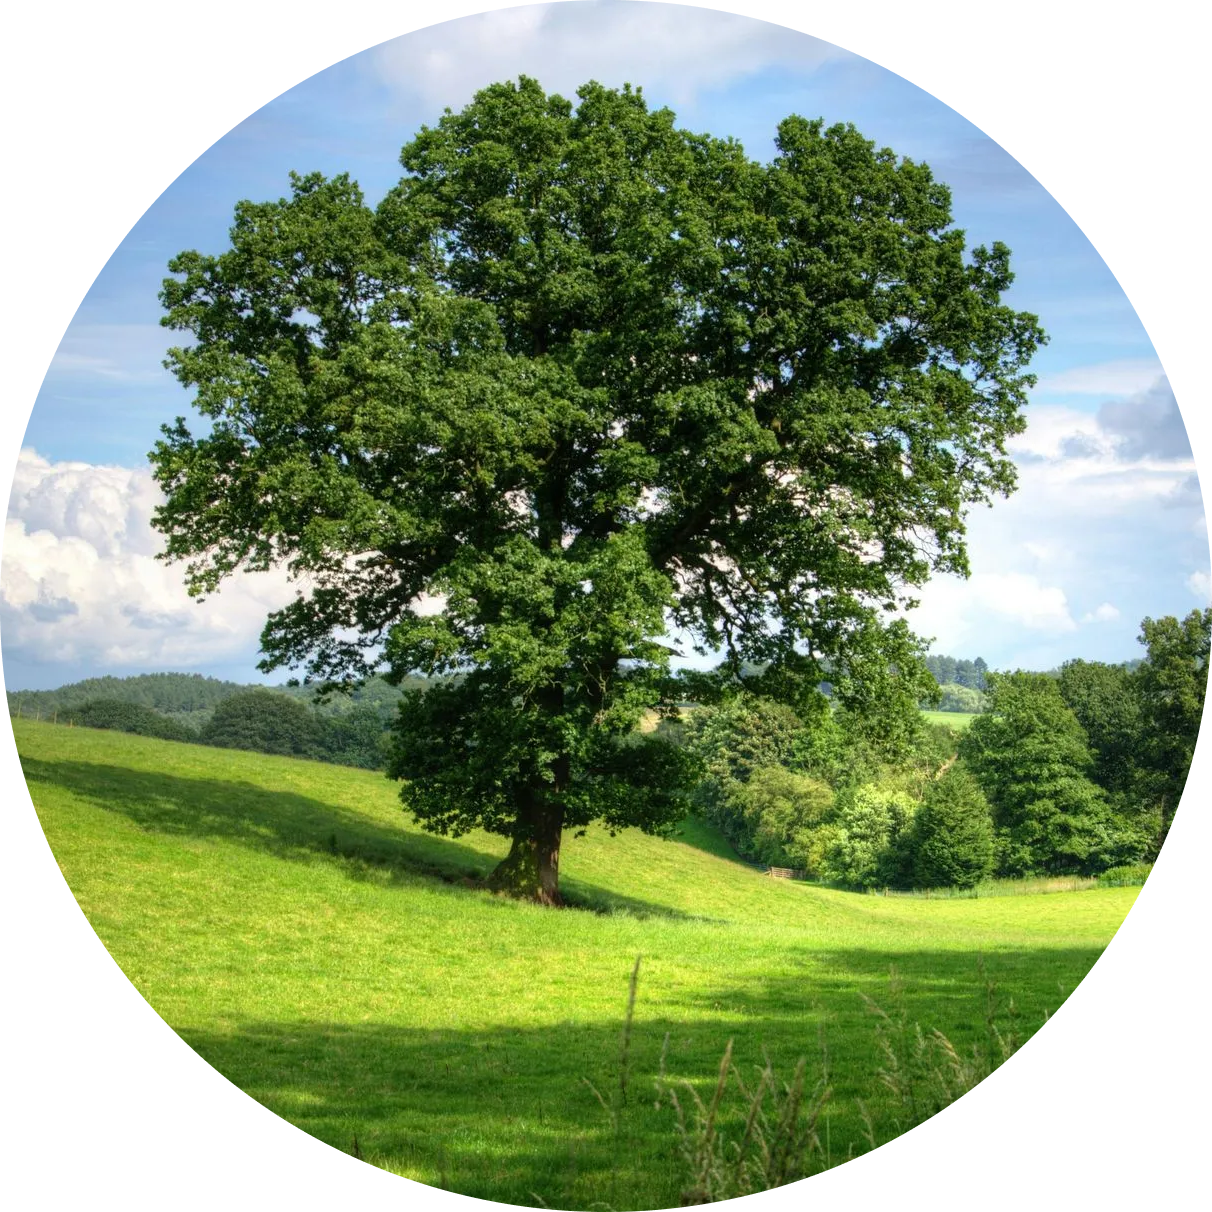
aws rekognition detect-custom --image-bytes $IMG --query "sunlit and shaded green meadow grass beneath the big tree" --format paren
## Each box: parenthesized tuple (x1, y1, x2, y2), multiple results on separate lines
(12, 720, 1138, 1212)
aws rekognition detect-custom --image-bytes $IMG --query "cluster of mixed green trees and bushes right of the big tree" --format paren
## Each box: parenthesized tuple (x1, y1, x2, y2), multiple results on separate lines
(657, 610, 1212, 888)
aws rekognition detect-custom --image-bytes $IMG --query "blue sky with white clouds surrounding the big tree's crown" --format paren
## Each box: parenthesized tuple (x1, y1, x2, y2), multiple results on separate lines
(0, 0, 1212, 691)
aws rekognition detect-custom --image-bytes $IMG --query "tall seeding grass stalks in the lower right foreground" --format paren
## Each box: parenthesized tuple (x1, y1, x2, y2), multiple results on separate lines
(557, 956, 1019, 1212)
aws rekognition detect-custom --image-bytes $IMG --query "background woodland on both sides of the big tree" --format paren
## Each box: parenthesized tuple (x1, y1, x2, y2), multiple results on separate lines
(7, 610, 1212, 888)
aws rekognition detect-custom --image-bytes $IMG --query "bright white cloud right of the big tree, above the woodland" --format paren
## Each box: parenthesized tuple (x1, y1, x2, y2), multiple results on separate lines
(909, 363, 1197, 668)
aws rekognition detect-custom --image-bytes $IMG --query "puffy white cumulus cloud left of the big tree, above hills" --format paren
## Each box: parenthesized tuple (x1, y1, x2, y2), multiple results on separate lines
(0, 450, 295, 669)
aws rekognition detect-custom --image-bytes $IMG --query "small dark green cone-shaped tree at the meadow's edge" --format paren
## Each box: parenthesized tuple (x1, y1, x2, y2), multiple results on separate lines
(913, 765, 994, 888)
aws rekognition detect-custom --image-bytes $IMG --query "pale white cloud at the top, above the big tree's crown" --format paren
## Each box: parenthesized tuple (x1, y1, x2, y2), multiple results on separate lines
(367, 0, 856, 109)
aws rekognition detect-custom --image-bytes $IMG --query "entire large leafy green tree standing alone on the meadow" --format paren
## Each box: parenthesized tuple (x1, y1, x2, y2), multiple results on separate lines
(152, 78, 1044, 903)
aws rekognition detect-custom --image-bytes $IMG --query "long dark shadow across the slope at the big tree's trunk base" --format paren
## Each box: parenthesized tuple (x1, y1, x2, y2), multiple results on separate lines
(21, 756, 690, 919)
